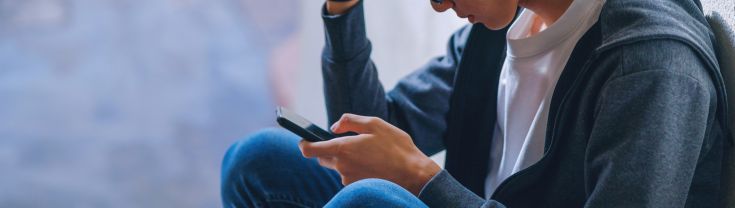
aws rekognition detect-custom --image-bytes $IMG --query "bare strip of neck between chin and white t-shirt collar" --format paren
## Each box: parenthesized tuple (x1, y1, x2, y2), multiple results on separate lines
(518, 0, 573, 25)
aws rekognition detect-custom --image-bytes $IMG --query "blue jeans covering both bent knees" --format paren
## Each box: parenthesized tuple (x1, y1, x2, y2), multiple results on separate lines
(221, 129, 427, 208)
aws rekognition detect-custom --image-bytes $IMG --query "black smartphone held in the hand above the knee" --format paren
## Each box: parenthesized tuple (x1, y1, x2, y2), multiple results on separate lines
(276, 106, 339, 142)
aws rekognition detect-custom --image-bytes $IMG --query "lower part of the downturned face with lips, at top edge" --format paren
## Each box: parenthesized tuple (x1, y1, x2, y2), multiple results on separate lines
(431, 0, 519, 30)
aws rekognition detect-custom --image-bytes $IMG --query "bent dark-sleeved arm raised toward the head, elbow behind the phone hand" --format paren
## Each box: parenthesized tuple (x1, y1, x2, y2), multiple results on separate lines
(322, 2, 469, 155)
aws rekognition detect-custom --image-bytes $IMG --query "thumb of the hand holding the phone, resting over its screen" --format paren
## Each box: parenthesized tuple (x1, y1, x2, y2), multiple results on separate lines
(331, 113, 386, 134)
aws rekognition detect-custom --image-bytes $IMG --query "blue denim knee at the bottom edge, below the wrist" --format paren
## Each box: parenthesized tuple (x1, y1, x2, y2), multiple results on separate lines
(325, 179, 428, 208)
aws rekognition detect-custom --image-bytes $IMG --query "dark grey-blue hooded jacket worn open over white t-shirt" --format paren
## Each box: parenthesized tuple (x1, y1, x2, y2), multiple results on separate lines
(322, 0, 729, 207)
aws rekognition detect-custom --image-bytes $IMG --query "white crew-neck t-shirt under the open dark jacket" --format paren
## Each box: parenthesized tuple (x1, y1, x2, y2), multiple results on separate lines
(485, 0, 605, 198)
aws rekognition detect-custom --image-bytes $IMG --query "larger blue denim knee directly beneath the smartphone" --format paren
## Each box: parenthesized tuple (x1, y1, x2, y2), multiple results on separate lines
(221, 129, 342, 207)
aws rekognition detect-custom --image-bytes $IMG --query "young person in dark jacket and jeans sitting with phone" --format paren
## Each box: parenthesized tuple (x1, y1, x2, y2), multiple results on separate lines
(222, 0, 732, 207)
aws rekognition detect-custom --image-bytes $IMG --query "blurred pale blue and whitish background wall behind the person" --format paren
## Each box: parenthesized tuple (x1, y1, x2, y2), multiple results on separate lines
(0, 0, 463, 207)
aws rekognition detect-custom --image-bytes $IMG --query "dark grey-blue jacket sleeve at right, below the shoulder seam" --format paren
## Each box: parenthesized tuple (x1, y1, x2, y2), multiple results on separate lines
(585, 41, 716, 207)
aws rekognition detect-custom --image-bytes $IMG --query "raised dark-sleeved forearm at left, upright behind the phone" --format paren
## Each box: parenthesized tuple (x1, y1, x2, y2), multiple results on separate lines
(322, 1, 390, 124)
